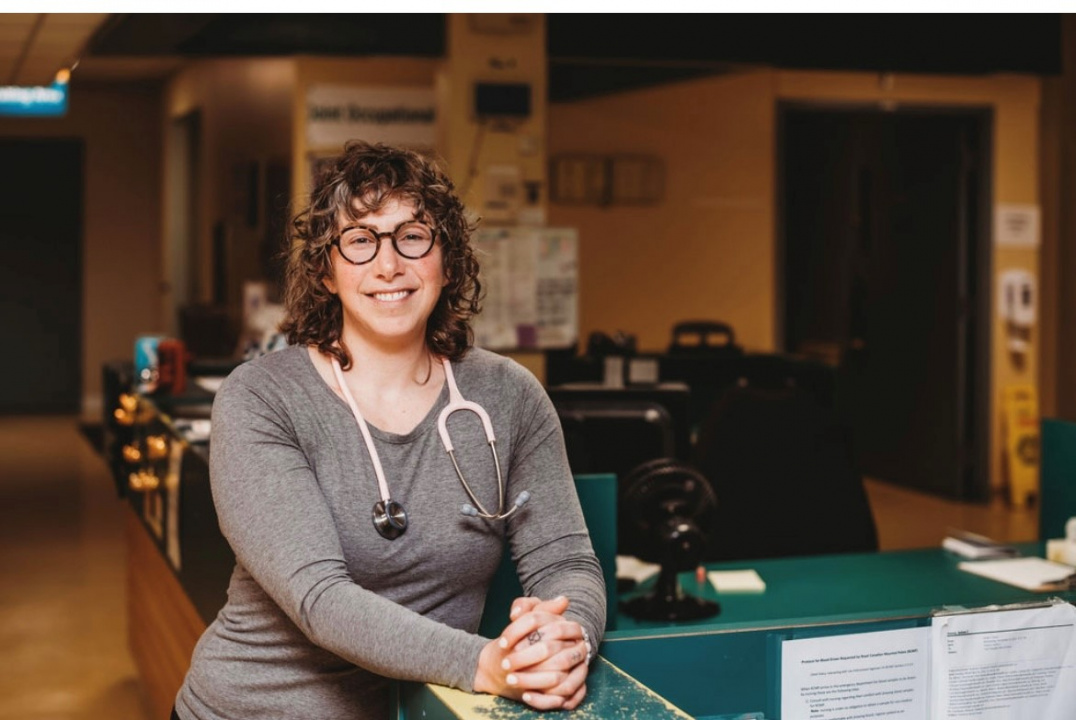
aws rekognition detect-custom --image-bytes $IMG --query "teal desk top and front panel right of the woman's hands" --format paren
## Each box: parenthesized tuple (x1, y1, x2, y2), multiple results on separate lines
(402, 543, 1076, 720)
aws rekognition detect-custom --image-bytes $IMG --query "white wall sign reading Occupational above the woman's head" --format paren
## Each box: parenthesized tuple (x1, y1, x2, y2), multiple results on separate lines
(307, 85, 436, 150)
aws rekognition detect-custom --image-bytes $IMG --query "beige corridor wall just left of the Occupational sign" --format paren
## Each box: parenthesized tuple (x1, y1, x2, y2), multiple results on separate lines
(157, 58, 296, 312)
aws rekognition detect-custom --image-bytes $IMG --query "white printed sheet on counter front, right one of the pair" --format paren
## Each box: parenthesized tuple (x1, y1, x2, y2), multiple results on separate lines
(930, 603, 1076, 720)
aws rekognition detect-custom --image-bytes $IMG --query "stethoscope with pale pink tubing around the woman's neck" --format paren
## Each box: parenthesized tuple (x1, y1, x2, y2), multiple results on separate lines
(332, 357, 530, 540)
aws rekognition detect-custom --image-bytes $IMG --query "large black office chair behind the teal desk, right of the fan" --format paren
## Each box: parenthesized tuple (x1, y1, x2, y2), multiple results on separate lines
(693, 356, 878, 561)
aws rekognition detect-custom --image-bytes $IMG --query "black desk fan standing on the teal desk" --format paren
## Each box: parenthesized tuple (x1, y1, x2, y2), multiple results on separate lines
(618, 457, 721, 621)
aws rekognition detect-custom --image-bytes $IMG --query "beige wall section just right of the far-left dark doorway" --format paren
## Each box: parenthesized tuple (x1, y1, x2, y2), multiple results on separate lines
(0, 85, 160, 419)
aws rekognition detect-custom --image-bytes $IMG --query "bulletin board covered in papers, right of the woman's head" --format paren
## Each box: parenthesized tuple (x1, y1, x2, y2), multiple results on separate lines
(472, 227, 579, 350)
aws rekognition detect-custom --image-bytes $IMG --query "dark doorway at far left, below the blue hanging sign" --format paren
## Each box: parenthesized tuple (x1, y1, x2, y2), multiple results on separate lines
(0, 139, 83, 414)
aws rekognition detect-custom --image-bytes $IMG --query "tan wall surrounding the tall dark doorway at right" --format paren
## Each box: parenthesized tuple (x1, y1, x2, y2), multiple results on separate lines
(550, 70, 1040, 486)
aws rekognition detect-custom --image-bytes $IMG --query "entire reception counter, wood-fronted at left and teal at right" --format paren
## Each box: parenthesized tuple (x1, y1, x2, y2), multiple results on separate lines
(102, 365, 1076, 720)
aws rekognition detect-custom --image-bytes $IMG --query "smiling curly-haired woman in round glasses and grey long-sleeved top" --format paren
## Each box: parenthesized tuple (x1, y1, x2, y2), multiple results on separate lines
(174, 143, 605, 720)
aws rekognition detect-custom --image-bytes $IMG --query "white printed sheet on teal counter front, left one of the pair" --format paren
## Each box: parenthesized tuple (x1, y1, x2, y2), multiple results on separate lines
(781, 627, 931, 720)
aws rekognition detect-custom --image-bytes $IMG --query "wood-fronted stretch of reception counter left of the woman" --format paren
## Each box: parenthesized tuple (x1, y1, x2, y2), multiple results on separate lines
(102, 362, 235, 718)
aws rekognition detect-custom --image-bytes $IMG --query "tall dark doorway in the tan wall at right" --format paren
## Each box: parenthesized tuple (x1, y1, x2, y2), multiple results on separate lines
(779, 105, 992, 500)
